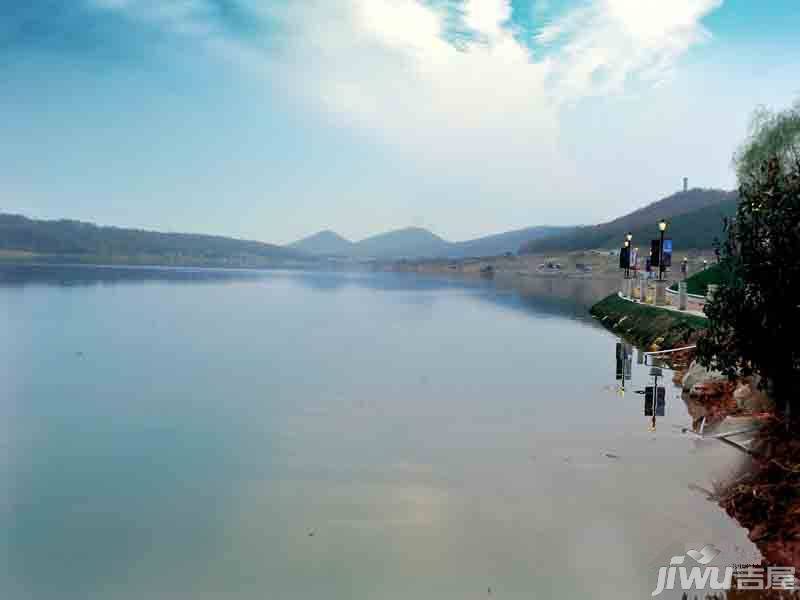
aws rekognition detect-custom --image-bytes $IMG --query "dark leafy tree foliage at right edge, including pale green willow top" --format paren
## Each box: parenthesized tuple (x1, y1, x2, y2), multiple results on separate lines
(697, 105, 800, 413)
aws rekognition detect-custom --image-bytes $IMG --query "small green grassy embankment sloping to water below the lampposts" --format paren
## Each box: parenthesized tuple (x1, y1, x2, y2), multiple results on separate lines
(589, 294, 707, 349)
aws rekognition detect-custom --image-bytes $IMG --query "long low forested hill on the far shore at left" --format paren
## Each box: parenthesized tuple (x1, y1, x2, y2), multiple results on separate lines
(0, 214, 305, 265)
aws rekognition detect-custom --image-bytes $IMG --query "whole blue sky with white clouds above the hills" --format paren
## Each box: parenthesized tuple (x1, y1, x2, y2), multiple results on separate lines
(0, 0, 800, 243)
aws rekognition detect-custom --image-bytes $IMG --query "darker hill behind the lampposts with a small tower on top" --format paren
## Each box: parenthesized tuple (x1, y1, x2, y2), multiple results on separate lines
(522, 189, 737, 253)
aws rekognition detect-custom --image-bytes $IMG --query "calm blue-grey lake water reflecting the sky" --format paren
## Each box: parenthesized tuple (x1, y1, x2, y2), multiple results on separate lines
(0, 267, 753, 600)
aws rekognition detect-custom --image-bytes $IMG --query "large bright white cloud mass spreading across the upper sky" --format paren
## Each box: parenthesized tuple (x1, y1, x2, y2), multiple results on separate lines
(86, 0, 722, 234)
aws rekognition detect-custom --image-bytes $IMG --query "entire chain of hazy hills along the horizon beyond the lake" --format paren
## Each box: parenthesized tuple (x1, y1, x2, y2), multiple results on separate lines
(0, 189, 738, 266)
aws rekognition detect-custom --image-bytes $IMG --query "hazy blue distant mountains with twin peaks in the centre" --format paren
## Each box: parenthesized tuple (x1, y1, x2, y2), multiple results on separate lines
(289, 226, 571, 259)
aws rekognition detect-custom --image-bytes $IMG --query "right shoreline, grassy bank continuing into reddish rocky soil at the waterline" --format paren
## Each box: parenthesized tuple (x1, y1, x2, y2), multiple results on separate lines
(590, 294, 800, 584)
